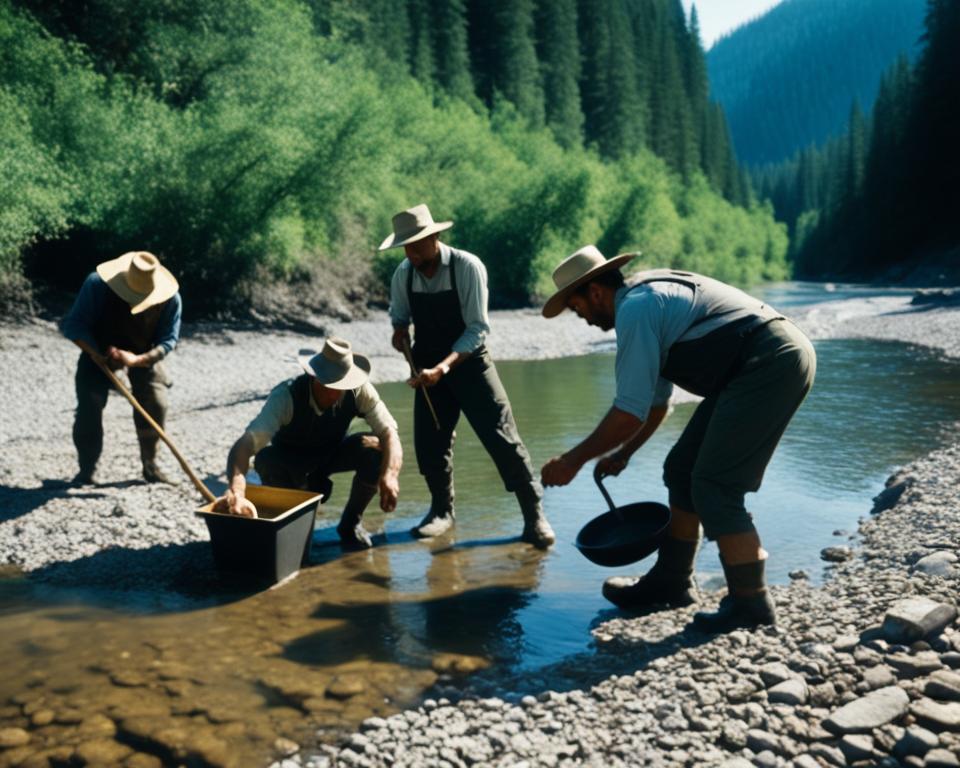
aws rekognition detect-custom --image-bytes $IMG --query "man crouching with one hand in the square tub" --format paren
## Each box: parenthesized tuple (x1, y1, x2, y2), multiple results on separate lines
(227, 339, 403, 549)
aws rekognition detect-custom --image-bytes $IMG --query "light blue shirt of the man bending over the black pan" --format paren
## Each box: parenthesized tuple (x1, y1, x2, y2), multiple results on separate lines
(613, 282, 704, 421)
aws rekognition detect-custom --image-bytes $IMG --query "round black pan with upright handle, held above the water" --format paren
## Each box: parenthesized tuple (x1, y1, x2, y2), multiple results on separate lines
(574, 470, 670, 568)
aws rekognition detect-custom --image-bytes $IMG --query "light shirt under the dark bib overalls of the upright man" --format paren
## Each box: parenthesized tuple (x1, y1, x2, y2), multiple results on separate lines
(390, 243, 490, 355)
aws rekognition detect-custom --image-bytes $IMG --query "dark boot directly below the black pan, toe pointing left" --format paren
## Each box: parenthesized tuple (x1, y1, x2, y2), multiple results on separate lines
(603, 537, 700, 611)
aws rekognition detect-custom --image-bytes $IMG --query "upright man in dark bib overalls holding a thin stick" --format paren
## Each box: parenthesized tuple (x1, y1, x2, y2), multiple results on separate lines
(380, 205, 556, 548)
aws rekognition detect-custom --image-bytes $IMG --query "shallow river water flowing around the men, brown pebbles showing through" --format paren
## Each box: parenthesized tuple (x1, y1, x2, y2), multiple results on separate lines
(0, 286, 960, 766)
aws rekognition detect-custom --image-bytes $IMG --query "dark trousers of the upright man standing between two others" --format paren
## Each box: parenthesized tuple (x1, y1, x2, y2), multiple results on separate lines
(413, 350, 533, 491)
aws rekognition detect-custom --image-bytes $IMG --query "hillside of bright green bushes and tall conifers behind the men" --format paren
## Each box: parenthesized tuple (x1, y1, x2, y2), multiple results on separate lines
(0, 0, 787, 314)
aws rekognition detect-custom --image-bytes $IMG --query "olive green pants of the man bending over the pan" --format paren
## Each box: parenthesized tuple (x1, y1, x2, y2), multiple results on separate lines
(663, 320, 817, 539)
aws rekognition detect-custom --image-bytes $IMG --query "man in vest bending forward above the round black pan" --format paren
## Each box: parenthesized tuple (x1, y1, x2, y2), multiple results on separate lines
(542, 245, 816, 632)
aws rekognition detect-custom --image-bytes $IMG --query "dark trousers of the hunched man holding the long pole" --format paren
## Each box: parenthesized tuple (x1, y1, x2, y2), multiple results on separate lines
(73, 353, 169, 474)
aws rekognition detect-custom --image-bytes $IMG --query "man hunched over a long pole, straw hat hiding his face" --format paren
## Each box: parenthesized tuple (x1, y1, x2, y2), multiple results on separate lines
(60, 251, 181, 485)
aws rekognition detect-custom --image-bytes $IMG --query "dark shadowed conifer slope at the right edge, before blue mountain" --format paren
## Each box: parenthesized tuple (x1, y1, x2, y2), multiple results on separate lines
(756, 0, 960, 276)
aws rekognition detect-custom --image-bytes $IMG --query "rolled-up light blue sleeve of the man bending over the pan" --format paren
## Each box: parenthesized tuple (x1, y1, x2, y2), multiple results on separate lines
(613, 297, 662, 421)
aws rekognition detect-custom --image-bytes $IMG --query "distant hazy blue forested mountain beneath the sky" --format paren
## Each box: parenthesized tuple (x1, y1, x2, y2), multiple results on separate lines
(707, 0, 925, 166)
